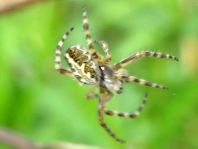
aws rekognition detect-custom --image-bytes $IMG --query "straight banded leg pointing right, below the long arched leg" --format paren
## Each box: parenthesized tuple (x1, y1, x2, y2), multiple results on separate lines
(121, 76, 168, 89)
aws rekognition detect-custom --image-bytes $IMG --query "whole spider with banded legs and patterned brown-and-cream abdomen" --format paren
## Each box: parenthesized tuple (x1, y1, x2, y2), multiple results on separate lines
(55, 8, 178, 143)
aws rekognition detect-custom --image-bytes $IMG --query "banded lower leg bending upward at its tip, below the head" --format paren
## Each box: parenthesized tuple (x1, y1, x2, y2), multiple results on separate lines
(104, 94, 148, 119)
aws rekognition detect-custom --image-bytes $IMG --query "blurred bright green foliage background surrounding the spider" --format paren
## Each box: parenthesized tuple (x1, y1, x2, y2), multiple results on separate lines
(0, 0, 198, 149)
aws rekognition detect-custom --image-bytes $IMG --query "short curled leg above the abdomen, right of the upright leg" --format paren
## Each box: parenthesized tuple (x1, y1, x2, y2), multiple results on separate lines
(95, 40, 111, 64)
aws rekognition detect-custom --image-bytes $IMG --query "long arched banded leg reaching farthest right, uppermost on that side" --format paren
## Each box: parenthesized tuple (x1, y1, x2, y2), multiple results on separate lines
(113, 51, 178, 69)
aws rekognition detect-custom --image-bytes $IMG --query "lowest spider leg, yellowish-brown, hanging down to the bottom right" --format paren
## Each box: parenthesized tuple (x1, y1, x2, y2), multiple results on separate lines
(98, 87, 125, 143)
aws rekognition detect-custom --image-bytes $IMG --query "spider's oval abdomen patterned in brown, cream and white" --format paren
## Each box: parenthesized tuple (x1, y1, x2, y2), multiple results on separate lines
(65, 46, 100, 84)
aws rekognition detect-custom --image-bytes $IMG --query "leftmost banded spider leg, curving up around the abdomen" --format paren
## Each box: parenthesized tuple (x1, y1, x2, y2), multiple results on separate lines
(55, 27, 74, 76)
